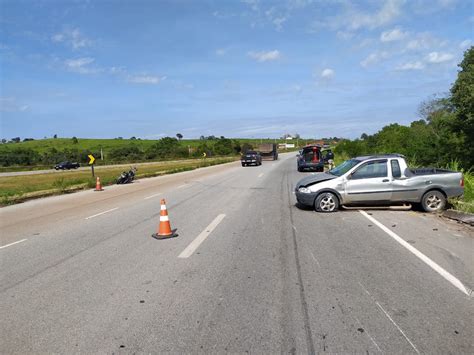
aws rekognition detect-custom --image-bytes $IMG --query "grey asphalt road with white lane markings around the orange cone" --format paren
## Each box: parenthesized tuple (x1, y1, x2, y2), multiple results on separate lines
(0, 154, 474, 354)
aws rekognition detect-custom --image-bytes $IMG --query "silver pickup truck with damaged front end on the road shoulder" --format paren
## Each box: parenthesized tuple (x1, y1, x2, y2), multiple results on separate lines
(295, 154, 464, 212)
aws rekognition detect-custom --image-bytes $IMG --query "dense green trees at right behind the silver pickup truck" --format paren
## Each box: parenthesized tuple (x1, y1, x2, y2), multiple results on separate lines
(335, 47, 474, 170)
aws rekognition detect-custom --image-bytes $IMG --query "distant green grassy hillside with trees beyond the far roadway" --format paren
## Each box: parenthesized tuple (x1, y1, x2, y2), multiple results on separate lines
(0, 137, 324, 171)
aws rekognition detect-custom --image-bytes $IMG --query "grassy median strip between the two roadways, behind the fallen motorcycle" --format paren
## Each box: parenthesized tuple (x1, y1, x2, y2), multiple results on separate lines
(0, 157, 239, 206)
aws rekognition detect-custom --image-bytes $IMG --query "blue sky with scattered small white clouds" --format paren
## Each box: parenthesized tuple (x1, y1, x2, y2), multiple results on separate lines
(0, 0, 474, 139)
